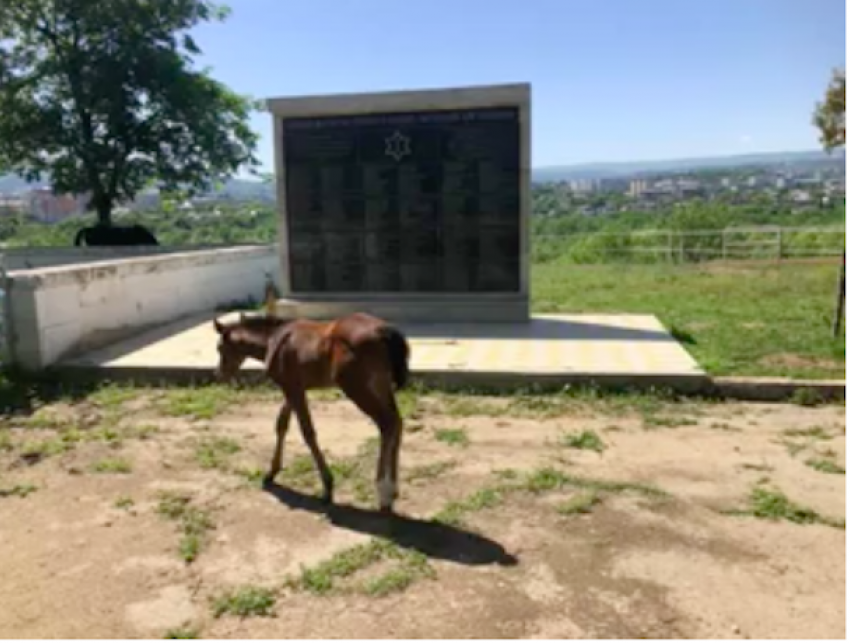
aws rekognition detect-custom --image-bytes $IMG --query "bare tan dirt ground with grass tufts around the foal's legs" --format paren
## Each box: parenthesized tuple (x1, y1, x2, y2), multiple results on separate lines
(0, 389, 846, 638)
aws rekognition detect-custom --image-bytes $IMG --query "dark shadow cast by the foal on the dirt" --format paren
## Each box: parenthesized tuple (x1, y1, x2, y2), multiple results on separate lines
(263, 482, 519, 567)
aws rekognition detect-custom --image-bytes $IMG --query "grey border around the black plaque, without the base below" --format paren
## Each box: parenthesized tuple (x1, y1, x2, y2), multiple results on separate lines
(265, 83, 531, 302)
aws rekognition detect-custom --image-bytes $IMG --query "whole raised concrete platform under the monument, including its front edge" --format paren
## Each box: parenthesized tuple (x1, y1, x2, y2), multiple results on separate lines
(54, 315, 710, 390)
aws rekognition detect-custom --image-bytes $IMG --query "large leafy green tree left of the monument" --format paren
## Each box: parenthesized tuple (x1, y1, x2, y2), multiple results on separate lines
(0, 0, 257, 225)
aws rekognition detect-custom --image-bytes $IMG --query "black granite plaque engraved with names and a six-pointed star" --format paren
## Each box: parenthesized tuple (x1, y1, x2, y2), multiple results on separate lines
(283, 108, 520, 292)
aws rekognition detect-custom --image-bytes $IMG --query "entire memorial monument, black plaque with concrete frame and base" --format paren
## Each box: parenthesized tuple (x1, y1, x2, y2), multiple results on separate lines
(267, 84, 531, 322)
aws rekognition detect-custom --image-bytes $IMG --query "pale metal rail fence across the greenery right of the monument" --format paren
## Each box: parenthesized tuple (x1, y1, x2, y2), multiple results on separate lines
(531, 226, 846, 263)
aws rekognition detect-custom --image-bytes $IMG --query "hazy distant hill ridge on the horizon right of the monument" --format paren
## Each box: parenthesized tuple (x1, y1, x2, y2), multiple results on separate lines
(532, 150, 844, 182)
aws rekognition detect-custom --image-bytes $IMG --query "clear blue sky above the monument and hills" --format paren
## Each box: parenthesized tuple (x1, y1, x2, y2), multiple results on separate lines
(189, 0, 846, 169)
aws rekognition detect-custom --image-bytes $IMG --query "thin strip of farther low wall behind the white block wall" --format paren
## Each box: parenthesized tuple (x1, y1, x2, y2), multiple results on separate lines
(0, 243, 264, 272)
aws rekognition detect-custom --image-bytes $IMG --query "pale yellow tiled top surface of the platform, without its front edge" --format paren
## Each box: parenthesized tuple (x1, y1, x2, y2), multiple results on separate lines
(66, 315, 704, 376)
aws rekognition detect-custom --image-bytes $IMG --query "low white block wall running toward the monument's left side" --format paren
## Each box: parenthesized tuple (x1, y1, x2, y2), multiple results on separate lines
(5, 246, 280, 370)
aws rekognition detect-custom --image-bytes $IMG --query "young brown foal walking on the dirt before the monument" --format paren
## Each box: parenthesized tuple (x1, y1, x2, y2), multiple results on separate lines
(213, 313, 410, 514)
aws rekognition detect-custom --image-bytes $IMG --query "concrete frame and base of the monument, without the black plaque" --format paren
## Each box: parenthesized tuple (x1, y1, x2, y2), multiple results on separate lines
(266, 83, 531, 322)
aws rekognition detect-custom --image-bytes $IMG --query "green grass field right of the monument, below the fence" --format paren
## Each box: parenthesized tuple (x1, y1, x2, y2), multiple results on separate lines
(532, 261, 845, 379)
